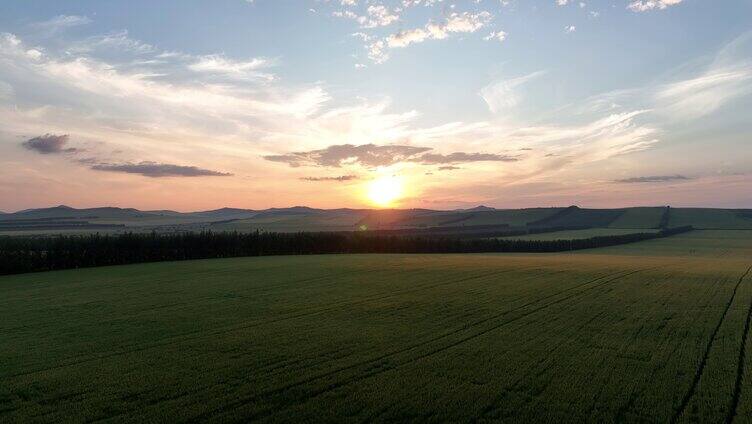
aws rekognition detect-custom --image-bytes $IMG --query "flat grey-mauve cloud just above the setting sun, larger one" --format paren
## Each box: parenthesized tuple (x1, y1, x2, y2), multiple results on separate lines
(264, 144, 431, 168)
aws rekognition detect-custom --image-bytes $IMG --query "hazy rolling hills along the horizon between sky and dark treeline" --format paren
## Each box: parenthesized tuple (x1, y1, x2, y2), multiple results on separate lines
(0, 205, 752, 235)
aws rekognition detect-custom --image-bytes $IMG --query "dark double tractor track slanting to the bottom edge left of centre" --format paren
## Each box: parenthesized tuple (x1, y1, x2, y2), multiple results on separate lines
(190, 269, 645, 422)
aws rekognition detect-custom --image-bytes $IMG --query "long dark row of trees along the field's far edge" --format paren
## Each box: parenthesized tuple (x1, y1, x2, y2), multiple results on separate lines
(0, 226, 692, 274)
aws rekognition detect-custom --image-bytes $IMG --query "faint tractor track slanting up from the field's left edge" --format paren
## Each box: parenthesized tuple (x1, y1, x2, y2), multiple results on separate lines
(2, 268, 532, 378)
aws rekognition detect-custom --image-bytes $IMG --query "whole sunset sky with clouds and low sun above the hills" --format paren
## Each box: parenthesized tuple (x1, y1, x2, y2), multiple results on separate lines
(0, 0, 752, 212)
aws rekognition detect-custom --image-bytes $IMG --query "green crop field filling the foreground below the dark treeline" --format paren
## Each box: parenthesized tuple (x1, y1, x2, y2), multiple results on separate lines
(0, 231, 752, 422)
